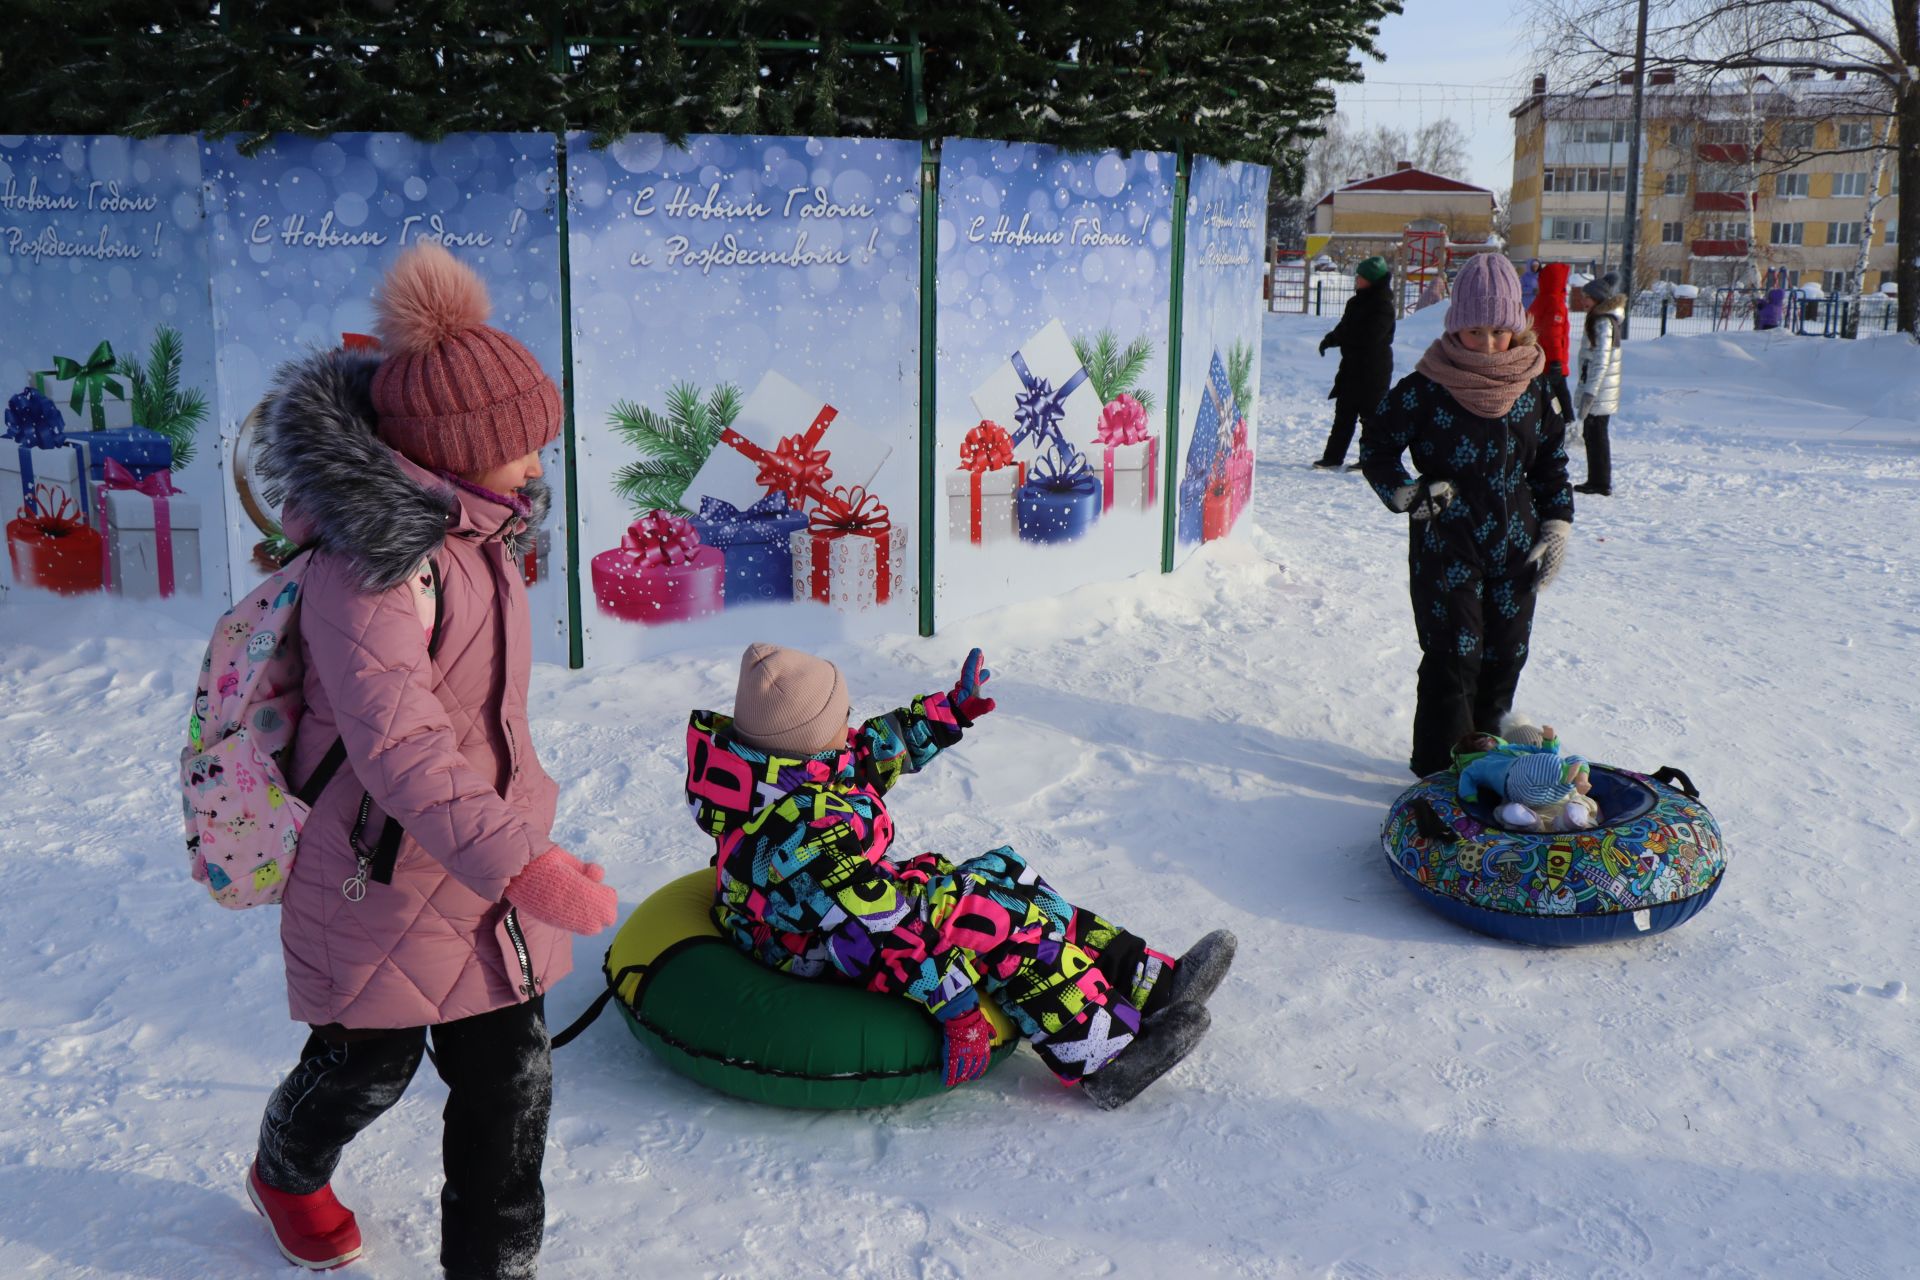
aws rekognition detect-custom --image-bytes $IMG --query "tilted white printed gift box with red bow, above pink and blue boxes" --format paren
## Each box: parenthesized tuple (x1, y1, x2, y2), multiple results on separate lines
(680, 372, 893, 510)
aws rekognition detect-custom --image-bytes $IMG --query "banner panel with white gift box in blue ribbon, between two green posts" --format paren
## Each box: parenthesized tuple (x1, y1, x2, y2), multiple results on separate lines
(935, 140, 1175, 620)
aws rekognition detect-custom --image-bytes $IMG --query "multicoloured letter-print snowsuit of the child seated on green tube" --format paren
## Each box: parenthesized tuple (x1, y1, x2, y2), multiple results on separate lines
(687, 693, 1164, 1082)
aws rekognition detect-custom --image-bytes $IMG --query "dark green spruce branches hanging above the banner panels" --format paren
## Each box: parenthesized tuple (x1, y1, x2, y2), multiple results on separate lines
(0, 0, 1400, 175)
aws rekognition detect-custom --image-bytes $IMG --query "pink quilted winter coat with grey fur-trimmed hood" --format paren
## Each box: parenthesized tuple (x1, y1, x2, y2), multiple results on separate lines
(259, 351, 572, 1029)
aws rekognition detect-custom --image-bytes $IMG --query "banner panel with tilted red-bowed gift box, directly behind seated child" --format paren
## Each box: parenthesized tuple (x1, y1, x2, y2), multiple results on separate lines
(568, 136, 920, 662)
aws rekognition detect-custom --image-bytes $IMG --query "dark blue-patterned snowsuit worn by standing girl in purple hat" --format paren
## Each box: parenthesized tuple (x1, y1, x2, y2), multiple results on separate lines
(1359, 364, 1572, 775)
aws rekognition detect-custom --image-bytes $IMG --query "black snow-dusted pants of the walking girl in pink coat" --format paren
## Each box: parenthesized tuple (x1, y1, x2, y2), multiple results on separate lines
(259, 996, 553, 1280)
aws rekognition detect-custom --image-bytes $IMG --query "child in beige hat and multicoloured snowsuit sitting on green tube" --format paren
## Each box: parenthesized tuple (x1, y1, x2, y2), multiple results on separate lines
(687, 645, 1235, 1107)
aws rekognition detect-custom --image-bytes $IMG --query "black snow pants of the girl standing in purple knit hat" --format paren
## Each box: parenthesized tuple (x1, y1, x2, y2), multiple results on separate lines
(1407, 564, 1536, 777)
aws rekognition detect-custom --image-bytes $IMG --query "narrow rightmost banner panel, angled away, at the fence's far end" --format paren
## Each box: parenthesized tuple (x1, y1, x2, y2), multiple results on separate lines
(1175, 155, 1267, 558)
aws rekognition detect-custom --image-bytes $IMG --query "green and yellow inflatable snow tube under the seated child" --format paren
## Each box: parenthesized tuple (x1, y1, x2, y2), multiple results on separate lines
(605, 871, 1018, 1109)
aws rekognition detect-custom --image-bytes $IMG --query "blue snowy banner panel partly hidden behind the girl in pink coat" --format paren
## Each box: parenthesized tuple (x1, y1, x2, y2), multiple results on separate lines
(204, 132, 570, 662)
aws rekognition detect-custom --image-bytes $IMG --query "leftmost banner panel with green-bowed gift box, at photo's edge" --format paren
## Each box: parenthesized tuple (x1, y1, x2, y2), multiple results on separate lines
(0, 136, 227, 606)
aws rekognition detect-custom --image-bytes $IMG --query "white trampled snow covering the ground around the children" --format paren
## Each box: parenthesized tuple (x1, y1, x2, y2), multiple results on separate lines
(0, 313, 1920, 1280)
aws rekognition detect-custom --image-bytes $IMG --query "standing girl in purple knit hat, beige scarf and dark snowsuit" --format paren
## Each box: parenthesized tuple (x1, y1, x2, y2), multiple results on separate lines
(1359, 253, 1572, 777)
